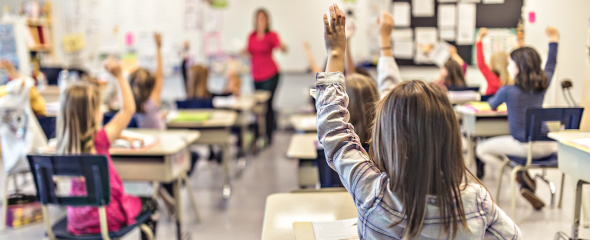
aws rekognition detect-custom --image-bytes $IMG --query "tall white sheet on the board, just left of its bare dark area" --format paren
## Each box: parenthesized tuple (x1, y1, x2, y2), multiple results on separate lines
(457, 3, 476, 45)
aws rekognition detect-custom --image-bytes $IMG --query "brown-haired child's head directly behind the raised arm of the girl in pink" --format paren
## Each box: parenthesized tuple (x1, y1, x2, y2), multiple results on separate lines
(129, 68, 156, 113)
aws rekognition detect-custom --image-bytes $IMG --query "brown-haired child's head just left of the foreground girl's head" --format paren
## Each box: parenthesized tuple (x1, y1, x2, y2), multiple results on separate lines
(346, 74, 379, 143)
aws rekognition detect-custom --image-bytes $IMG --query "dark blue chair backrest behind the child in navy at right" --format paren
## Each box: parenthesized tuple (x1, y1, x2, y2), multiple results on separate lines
(526, 108, 584, 141)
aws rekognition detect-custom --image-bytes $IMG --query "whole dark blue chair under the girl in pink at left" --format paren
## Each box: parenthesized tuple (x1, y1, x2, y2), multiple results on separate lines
(27, 155, 153, 240)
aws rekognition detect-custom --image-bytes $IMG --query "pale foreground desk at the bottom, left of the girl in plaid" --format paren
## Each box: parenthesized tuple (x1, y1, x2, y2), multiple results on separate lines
(262, 191, 358, 240)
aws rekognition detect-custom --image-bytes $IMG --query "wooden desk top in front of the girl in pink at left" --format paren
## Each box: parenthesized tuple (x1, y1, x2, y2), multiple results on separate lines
(110, 129, 200, 157)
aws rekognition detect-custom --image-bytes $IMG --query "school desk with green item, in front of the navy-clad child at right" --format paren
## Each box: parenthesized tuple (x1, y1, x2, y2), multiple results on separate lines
(455, 106, 510, 165)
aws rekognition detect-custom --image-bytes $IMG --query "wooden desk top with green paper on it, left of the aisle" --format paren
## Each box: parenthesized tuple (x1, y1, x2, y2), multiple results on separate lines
(166, 109, 238, 128)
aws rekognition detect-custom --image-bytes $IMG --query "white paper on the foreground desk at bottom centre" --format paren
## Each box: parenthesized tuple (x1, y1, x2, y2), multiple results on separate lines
(312, 218, 359, 240)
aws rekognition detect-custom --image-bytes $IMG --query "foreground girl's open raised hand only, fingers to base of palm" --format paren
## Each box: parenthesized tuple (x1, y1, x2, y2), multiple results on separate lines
(324, 4, 346, 56)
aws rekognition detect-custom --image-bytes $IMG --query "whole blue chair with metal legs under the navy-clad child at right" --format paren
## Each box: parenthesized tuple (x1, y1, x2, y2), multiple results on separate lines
(496, 108, 584, 218)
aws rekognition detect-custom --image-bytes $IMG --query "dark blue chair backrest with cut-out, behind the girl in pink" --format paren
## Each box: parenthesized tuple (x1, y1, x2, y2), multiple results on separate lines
(27, 155, 111, 206)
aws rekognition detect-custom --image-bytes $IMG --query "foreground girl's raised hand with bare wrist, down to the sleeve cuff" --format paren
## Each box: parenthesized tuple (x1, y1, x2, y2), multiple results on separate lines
(324, 4, 346, 72)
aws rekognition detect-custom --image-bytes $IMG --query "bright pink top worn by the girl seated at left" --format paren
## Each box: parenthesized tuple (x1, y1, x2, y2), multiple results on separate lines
(67, 128, 141, 235)
